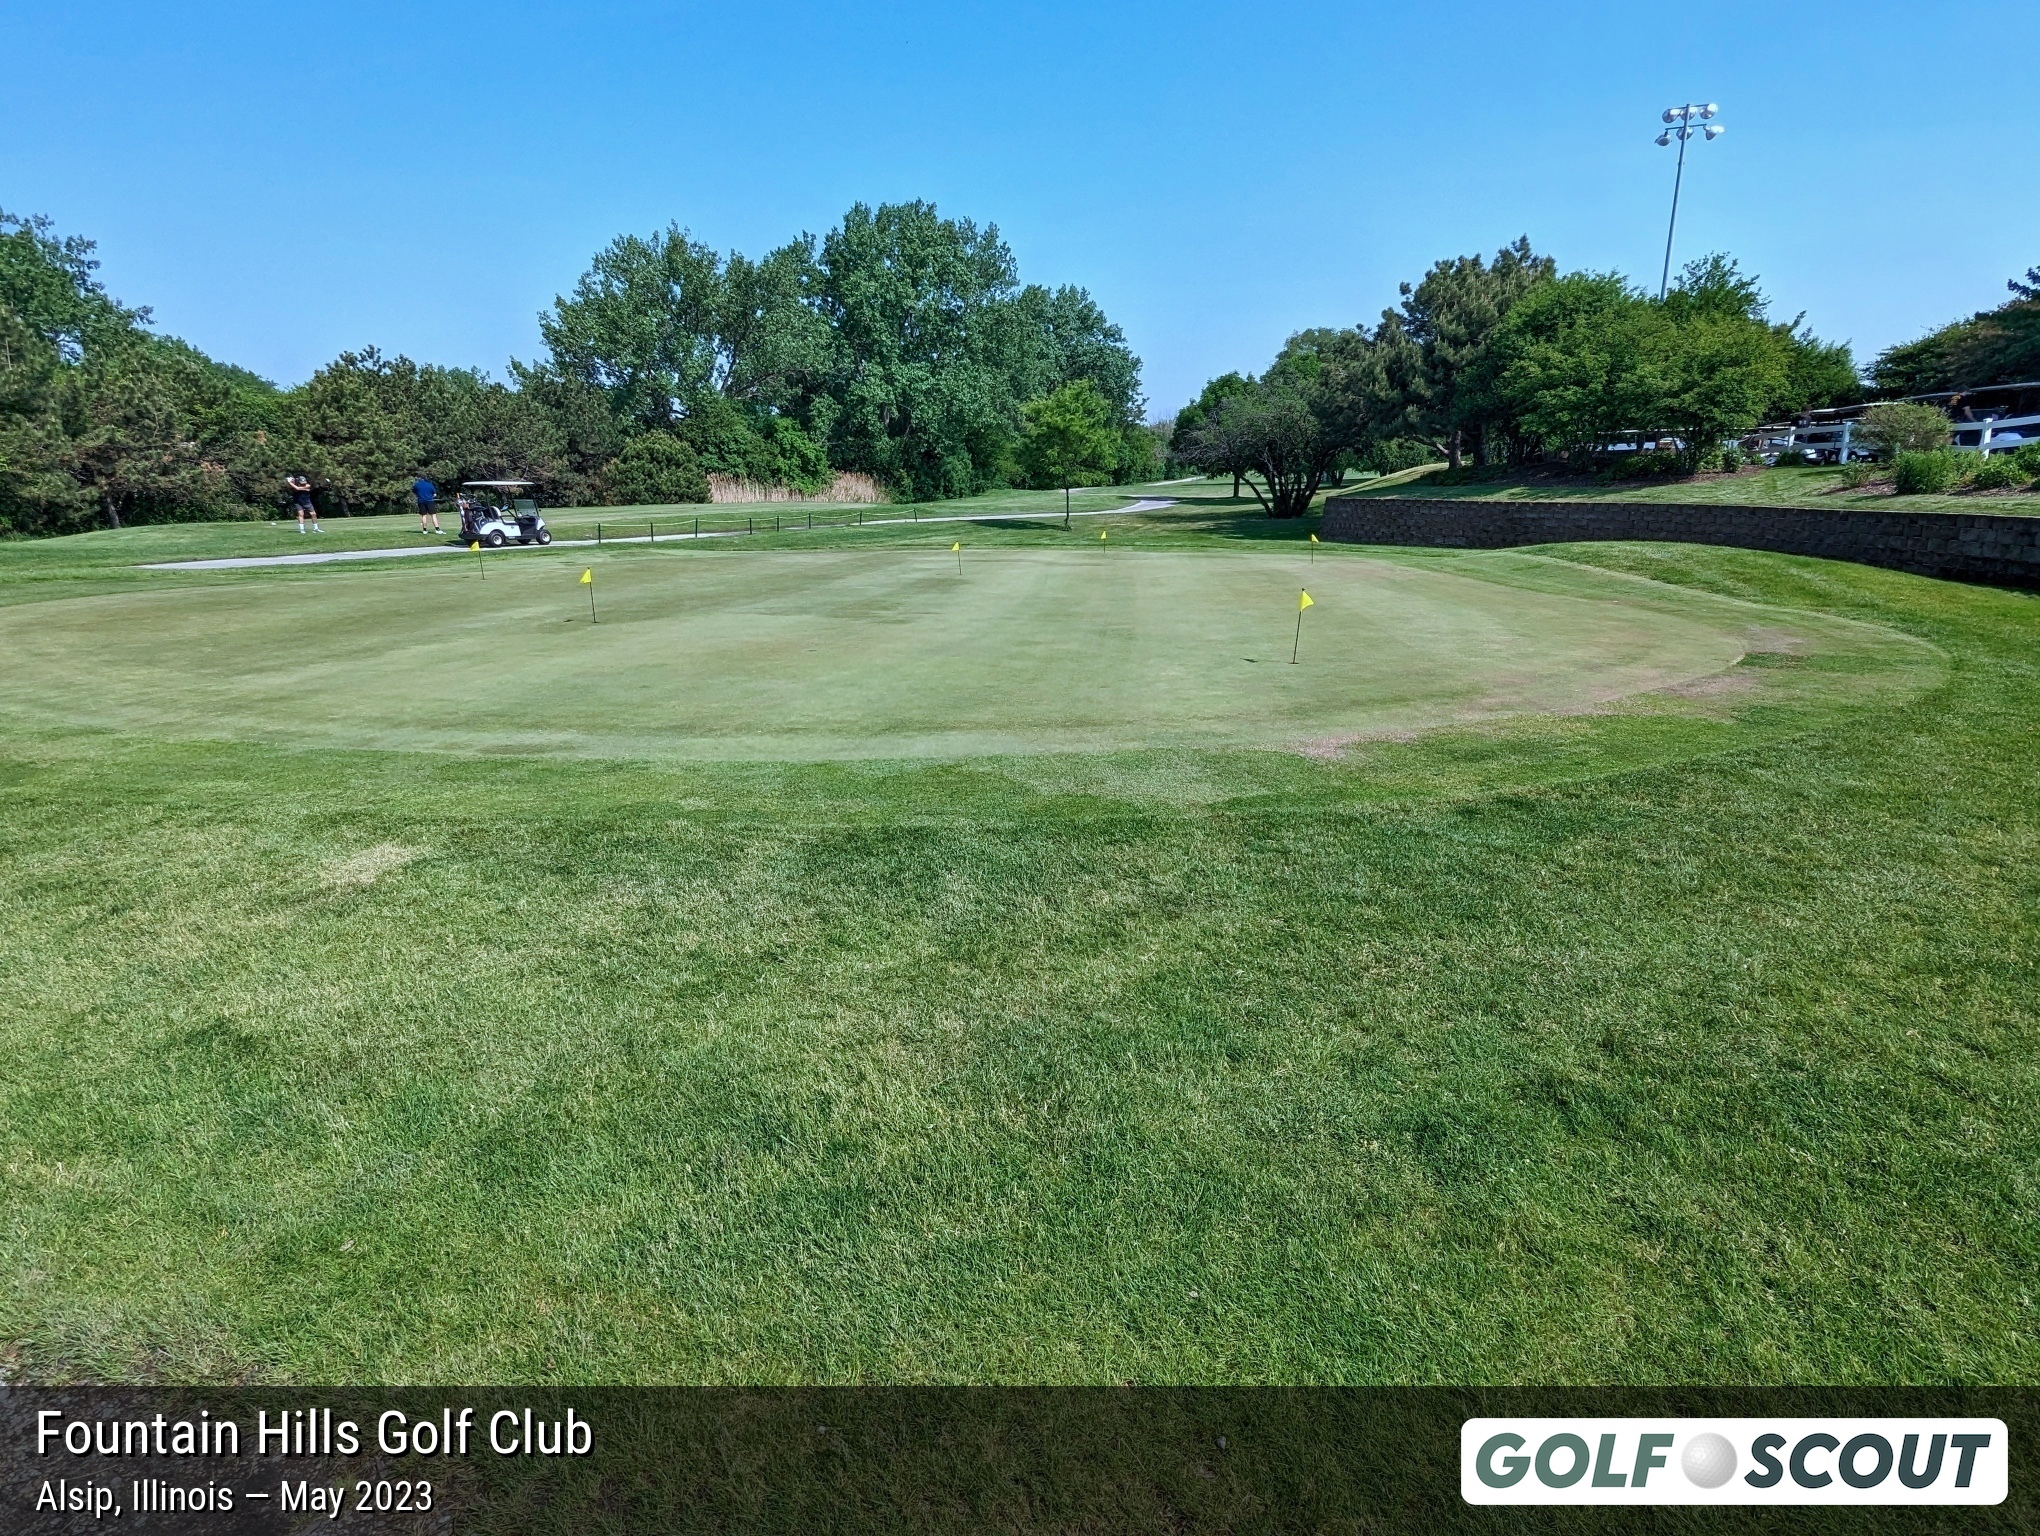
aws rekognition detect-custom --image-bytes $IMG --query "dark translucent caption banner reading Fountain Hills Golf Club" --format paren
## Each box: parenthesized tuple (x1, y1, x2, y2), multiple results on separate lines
(0, 1387, 2040, 1536)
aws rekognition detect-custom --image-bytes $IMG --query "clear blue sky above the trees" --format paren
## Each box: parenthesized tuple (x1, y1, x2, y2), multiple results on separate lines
(0, 0, 2040, 414)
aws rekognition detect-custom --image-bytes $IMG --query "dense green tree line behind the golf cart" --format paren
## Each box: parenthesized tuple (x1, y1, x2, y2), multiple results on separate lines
(0, 202, 1157, 534)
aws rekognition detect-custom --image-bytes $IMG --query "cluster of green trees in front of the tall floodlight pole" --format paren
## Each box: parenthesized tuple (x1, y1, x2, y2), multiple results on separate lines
(1171, 239, 1863, 516)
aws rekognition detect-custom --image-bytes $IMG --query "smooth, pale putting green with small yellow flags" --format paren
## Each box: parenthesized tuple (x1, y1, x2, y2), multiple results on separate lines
(0, 547, 1901, 759)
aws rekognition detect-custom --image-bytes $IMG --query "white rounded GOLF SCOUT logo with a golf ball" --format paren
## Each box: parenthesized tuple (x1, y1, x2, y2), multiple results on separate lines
(1459, 1418, 2009, 1503)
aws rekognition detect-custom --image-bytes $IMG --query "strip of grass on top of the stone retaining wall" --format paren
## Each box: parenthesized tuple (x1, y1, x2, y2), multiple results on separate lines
(1332, 469, 2040, 516)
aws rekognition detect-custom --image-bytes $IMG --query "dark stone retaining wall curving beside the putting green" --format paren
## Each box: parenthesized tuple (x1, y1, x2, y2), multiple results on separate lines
(1318, 496, 2040, 587)
